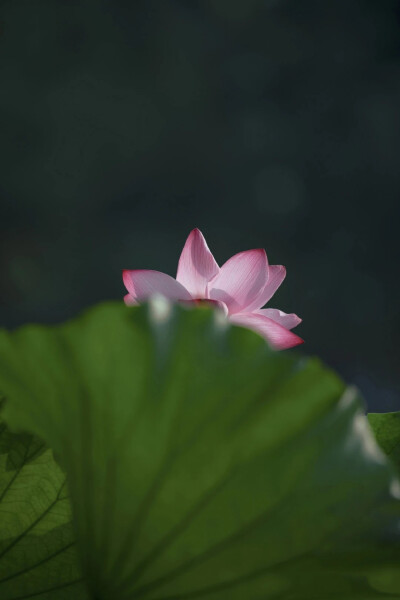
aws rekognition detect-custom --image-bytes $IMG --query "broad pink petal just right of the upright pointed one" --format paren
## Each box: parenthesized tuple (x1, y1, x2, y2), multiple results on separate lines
(208, 249, 268, 314)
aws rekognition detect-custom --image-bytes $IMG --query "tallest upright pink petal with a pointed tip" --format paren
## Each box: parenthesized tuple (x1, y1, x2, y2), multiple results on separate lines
(176, 229, 219, 298)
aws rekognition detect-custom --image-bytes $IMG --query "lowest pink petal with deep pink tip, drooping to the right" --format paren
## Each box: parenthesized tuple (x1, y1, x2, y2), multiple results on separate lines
(229, 313, 304, 350)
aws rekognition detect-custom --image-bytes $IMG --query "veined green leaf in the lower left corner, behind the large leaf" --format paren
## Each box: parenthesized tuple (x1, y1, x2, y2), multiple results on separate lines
(0, 422, 87, 600)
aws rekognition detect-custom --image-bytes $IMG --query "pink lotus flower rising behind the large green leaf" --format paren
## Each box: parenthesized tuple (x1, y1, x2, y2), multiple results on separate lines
(123, 229, 303, 350)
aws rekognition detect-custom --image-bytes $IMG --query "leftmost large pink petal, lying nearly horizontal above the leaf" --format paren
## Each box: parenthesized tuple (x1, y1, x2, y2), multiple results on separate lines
(122, 269, 192, 302)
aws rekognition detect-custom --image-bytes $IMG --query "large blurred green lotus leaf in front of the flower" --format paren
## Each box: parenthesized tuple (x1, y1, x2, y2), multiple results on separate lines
(0, 302, 400, 600)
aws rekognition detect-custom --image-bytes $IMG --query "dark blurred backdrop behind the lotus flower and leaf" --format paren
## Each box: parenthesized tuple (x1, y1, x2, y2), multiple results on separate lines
(0, 0, 400, 411)
